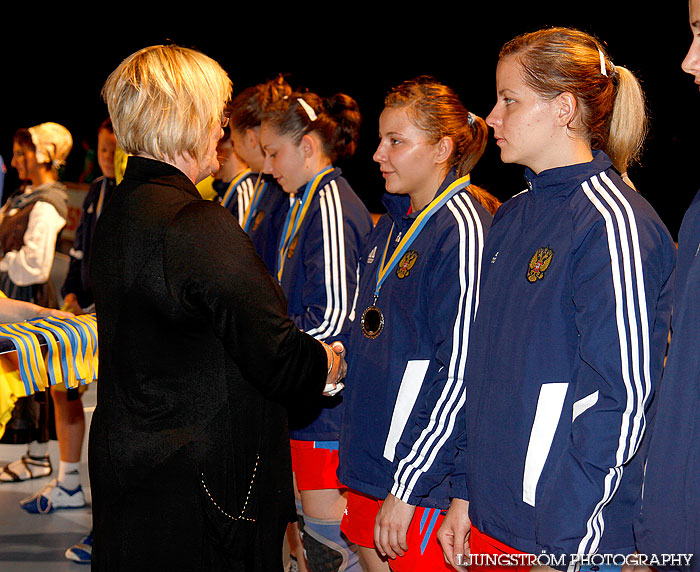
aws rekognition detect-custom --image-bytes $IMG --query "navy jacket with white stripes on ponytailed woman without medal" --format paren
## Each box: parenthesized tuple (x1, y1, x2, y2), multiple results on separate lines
(451, 151, 675, 561)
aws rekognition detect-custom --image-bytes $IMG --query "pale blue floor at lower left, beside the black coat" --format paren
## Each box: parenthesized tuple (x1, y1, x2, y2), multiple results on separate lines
(0, 385, 97, 572)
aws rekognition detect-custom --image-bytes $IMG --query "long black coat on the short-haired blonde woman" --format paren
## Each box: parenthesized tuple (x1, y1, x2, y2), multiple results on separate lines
(89, 157, 326, 572)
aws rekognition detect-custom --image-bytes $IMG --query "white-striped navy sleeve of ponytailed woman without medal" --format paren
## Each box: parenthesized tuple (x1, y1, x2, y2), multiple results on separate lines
(531, 187, 674, 554)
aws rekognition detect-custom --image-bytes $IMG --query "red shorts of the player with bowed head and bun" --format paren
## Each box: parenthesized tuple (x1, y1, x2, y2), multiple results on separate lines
(289, 439, 345, 491)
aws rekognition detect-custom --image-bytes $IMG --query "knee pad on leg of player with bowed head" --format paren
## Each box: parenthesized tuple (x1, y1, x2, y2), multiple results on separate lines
(299, 514, 361, 572)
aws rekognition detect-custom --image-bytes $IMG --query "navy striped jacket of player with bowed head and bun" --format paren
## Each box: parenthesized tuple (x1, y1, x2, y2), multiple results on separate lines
(278, 168, 372, 441)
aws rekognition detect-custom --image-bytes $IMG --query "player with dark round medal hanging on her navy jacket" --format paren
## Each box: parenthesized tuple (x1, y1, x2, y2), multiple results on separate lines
(338, 77, 498, 572)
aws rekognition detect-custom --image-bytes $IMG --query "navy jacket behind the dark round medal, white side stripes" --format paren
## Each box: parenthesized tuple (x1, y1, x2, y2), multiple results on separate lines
(338, 170, 492, 509)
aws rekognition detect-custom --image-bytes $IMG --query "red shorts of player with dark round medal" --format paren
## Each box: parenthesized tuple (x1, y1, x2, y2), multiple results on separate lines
(340, 489, 454, 572)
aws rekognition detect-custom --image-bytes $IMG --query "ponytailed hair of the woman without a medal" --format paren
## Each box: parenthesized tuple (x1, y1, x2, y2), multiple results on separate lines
(500, 28, 647, 173)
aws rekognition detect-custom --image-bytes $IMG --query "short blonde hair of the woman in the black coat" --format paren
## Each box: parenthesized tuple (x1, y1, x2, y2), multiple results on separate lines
(102, 45, 232, 162)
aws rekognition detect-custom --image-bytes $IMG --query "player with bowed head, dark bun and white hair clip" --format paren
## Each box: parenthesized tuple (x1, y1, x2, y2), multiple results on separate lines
(260, 93, 372, 570)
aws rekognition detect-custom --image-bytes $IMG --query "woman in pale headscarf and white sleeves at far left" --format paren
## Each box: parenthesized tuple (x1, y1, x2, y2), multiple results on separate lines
(0, 122, 72, 482)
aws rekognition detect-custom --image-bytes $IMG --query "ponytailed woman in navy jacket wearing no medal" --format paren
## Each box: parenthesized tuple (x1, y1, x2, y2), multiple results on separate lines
(439, 28, 675, 572)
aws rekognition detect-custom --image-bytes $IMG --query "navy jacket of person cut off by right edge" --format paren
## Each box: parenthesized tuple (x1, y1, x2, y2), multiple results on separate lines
(635, 187, 700, 571)
